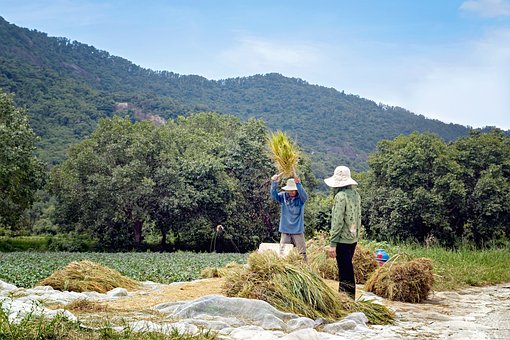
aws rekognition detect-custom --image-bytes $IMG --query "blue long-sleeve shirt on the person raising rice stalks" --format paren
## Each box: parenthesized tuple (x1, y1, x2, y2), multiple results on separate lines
(271, 182, 308, 234)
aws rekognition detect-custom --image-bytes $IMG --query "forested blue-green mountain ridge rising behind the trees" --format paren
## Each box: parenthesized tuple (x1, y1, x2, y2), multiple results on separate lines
(0, 17, 474, 176)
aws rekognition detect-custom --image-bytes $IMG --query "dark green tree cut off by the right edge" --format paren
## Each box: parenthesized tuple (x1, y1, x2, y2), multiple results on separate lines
(451, 129, 510, 246)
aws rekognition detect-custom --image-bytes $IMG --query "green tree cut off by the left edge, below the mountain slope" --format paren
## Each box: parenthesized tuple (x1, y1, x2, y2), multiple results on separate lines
(0, 91, 45, 227)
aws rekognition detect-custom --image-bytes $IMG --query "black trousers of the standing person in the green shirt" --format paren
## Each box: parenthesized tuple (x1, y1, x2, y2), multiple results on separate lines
(336, 243, 357, 299)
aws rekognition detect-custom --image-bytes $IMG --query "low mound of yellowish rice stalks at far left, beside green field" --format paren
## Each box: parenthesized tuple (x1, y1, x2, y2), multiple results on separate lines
(39, 261, 139, 293)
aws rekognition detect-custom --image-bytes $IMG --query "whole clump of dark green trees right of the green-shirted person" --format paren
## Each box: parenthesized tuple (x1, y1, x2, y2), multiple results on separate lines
(362, 129, 510, 246)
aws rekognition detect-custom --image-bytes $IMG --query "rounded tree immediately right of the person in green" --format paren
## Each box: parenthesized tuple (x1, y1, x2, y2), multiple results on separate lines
(362, 133, 466, 245)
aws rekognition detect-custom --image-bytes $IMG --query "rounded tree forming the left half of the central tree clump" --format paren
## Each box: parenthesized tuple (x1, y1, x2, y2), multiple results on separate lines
(51, 117, 162, 249)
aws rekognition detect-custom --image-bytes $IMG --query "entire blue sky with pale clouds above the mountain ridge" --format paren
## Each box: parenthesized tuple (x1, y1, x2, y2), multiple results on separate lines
(0, 0, 510, 129)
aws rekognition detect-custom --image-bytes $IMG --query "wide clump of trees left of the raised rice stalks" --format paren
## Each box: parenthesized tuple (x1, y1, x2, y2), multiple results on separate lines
(51, 113, 314, 251)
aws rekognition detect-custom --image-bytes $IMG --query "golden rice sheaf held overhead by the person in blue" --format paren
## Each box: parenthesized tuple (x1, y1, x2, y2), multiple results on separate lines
(268, 130, 299, 177)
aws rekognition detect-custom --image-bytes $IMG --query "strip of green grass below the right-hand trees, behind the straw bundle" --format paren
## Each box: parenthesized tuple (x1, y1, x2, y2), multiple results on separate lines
(365, 242, 510, 291)
